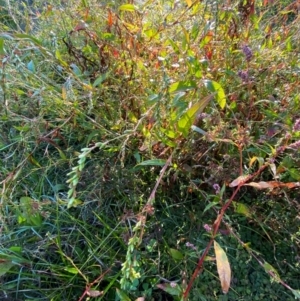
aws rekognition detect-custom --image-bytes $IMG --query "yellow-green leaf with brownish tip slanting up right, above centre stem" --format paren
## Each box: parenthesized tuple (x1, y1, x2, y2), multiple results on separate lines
(178, 95, 214, 137)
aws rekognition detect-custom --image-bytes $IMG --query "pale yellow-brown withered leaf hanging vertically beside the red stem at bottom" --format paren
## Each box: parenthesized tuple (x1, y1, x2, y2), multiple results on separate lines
(214, 241, 231, 294)
